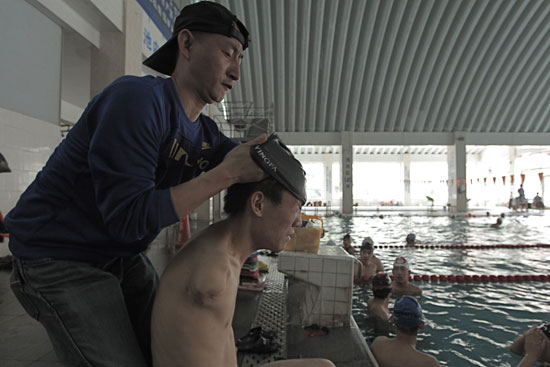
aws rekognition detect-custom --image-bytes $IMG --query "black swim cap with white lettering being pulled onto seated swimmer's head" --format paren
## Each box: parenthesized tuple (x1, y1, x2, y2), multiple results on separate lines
(250, 134, 307, 205)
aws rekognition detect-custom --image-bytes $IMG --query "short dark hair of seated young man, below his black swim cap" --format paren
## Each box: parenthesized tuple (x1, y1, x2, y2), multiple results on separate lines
(223, 177, 286, 215)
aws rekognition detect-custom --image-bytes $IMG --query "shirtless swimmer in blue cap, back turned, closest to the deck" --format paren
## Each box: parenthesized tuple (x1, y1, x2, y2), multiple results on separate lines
(371, 296, 439, 367)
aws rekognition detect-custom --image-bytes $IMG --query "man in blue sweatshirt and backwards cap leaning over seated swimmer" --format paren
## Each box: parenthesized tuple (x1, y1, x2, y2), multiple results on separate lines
(6, 2, 267, 367)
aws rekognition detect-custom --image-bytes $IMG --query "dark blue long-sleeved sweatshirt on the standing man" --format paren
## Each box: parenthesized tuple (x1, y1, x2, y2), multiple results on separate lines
(5, 76, 236, 262)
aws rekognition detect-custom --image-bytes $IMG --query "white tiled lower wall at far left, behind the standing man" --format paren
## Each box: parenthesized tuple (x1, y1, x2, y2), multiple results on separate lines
(0, 108, 61, 256)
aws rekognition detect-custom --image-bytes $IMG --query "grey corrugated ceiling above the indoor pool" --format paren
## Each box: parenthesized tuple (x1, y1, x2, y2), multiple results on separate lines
(179, 0, 550, 144)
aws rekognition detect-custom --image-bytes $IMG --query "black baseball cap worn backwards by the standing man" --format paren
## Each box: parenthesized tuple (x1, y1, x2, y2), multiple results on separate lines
(143, 1, 250, 75)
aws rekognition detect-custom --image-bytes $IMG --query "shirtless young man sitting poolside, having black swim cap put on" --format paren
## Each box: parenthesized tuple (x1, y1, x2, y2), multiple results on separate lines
(151, 135, 334, 367)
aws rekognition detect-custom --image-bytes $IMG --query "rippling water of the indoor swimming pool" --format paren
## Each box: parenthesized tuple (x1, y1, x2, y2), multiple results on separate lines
(323, 214, 550, 367)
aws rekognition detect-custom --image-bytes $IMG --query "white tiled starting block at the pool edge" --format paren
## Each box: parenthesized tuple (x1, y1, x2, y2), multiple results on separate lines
(278, 247, 353, 327)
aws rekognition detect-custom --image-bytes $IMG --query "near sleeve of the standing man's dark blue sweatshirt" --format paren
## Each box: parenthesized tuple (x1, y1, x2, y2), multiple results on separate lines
(88, 82, 179, 243)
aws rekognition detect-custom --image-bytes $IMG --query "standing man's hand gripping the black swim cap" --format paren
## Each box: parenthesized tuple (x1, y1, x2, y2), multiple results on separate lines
(221, 134, 267, 183)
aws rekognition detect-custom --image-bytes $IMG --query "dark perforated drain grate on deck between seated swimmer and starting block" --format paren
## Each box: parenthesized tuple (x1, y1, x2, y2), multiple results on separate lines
(241, 256, 287, 367)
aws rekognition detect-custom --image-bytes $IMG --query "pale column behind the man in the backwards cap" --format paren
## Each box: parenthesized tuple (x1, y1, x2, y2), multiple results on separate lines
(90, 0, 143, 96)
